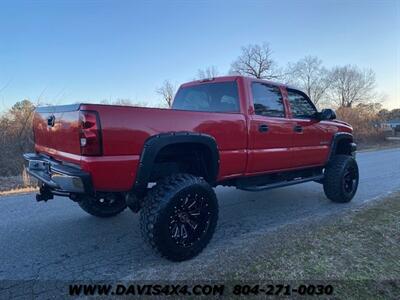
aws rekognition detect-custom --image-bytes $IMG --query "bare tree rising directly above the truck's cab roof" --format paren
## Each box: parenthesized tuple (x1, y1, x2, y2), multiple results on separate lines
(230, 43, 282, 79)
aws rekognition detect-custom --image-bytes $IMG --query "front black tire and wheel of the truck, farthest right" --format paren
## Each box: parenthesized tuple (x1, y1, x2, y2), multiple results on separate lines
(323, 155, 359, 203)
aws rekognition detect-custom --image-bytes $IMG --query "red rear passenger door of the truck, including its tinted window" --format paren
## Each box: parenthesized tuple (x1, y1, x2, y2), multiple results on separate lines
(247, 81, 293, 174)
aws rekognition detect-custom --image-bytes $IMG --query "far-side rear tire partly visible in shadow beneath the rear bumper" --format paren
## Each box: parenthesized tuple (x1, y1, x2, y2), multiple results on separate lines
(78, 193, 126, 218)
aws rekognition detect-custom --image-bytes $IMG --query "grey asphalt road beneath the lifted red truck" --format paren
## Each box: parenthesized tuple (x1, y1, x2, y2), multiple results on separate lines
(0, 149, 400, 280)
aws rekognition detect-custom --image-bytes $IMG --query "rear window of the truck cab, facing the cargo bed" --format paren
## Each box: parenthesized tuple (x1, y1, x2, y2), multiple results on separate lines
(172, 81, 239, 112)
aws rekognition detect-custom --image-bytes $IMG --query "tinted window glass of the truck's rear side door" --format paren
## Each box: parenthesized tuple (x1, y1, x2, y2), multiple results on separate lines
(251, 82, 285, 117)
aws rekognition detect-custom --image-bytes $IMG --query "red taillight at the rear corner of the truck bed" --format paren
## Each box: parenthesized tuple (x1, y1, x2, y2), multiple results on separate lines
(79, 110, 102, 156)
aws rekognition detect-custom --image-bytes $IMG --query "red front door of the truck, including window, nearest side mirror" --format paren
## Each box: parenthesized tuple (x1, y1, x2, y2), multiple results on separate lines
(287, 89, 330, 167)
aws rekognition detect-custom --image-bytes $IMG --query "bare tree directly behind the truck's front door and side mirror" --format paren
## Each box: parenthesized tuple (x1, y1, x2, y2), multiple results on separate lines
(286, 56, 330, 105)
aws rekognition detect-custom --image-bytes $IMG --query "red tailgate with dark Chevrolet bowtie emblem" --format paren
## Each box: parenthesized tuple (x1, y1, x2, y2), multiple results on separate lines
(33, 104, 81, 162)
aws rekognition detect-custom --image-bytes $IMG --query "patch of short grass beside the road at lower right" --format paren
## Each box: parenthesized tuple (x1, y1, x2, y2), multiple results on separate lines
(211, 193, 400, 299)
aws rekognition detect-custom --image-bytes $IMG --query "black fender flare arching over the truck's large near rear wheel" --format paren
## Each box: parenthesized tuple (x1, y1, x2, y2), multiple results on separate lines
(133, 131, 220, 192)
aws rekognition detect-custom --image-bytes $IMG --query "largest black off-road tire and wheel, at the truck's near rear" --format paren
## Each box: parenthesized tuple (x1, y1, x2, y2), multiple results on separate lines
(140, 174, 218, 261)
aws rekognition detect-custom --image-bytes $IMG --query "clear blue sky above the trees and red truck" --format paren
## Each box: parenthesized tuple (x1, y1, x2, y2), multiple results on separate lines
(0, 0, 400, 111)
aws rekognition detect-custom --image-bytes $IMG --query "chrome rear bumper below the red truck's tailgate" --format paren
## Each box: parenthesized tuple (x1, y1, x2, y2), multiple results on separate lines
(24, 153, 93, 194)
